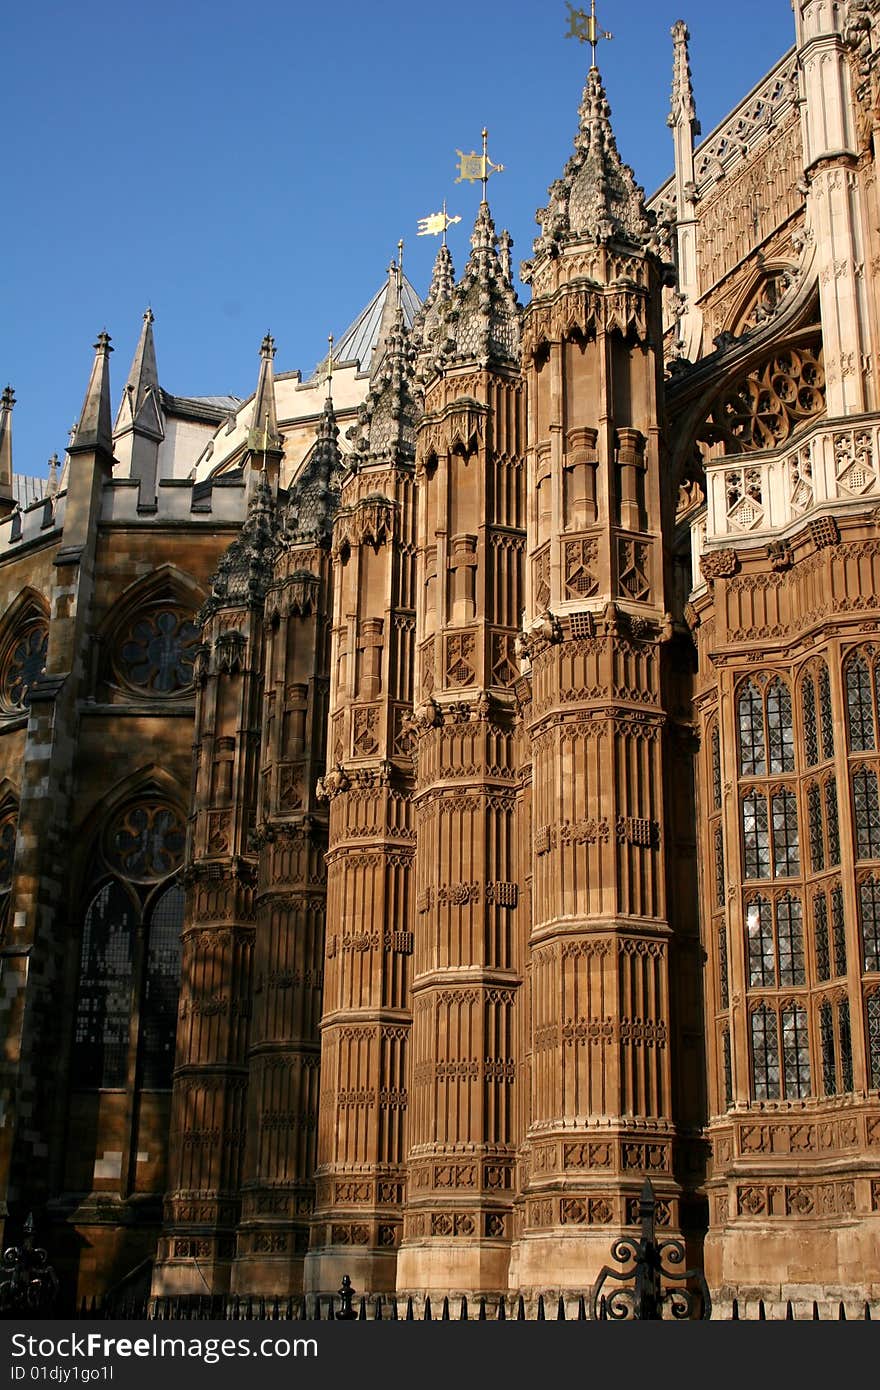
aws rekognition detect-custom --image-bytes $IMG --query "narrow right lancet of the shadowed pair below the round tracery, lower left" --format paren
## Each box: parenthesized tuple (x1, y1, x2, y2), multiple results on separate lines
(140, 884, 184, 1088)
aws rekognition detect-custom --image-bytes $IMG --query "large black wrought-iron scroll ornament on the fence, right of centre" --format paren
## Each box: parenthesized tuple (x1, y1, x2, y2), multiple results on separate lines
(591, 1177, 712, 1322)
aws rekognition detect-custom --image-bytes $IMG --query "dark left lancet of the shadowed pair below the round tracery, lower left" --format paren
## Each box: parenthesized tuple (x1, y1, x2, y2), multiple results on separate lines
(74, 880, 136, 1087)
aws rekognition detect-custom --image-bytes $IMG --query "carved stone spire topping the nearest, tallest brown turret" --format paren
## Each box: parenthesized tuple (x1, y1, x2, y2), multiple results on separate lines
(534, 67, 652, 257)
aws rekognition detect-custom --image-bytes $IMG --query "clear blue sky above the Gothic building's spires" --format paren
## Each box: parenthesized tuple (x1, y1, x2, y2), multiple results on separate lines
(0, 0, 794, 473)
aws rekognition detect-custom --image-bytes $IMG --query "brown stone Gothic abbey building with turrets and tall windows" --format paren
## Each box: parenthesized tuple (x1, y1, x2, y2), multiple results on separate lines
(0, 0, 880, 1304)
